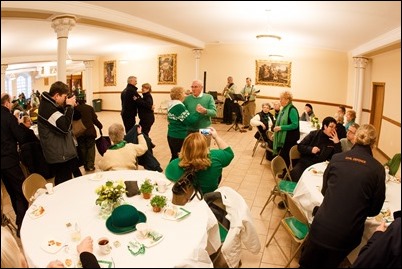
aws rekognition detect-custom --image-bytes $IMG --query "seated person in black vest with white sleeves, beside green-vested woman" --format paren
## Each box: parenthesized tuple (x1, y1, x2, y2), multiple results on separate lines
(250, 103, 274, 148)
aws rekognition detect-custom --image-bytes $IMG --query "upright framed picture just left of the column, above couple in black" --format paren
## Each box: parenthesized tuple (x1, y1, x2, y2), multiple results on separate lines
(158, 54, 177, 85)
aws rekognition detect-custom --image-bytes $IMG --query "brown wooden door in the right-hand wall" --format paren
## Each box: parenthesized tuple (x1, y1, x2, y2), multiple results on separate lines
(370, 82, 385, 146)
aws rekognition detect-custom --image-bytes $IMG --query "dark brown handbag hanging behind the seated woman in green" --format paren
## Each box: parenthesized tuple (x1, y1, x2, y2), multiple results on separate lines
(172, 169, 203, 205)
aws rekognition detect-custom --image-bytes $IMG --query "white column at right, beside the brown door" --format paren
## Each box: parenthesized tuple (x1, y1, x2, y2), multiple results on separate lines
(353, 57, 368, 122)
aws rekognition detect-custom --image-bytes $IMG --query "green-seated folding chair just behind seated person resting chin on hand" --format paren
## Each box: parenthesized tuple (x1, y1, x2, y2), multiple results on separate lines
(260, 155, 296, 215)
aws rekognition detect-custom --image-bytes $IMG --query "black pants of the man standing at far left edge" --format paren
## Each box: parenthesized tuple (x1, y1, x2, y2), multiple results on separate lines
(1, 165, 28, 230)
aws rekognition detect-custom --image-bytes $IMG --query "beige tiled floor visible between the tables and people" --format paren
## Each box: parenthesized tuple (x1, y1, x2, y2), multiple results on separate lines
(2, 111, 386, 268)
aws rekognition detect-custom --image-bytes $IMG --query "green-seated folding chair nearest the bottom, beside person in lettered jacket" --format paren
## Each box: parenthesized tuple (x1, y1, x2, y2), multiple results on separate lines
(265, 193, 310, 268)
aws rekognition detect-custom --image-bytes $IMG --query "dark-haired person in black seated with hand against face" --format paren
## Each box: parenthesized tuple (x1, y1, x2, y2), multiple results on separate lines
(290, 117, 342, 182)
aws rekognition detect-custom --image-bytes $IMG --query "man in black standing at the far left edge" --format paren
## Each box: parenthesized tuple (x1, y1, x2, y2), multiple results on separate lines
(1, 93, 28, 234)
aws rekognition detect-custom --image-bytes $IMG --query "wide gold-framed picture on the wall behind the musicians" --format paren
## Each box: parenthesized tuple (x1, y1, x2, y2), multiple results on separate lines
(255, 60, 292, 87)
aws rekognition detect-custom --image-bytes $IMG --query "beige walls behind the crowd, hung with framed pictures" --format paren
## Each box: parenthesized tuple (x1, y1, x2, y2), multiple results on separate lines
(90, 44, 401, 156)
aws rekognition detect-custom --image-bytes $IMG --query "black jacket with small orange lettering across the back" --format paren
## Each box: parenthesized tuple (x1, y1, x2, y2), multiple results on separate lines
(309, 144, 385, 251)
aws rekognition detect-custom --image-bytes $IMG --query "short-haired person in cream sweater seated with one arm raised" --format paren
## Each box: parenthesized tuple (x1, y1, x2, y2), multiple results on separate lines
(99, 123, 148, 171)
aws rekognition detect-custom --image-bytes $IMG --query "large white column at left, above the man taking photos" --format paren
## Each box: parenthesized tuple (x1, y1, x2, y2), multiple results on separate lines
(52, 15, 77, 83)
